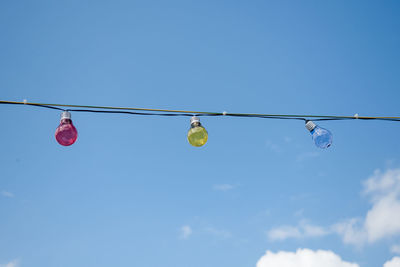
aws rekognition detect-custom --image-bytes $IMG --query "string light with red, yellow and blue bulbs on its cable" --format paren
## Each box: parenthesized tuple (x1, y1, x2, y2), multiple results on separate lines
(0, 100, 400, 149)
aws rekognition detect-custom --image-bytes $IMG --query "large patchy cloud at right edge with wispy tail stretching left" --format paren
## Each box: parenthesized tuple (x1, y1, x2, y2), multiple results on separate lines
(267, 169, 400, 258)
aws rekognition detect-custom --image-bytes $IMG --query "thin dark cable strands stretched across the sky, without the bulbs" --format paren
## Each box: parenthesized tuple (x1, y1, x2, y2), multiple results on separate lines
(0, 100, 400, 122)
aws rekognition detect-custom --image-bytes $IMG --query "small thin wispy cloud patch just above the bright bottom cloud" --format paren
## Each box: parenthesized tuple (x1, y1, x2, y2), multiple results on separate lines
(267, 221, 329, 241)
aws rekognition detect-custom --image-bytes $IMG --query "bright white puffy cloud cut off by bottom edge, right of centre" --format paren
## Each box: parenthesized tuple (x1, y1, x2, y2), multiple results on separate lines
(257, 249, 360, 267)
